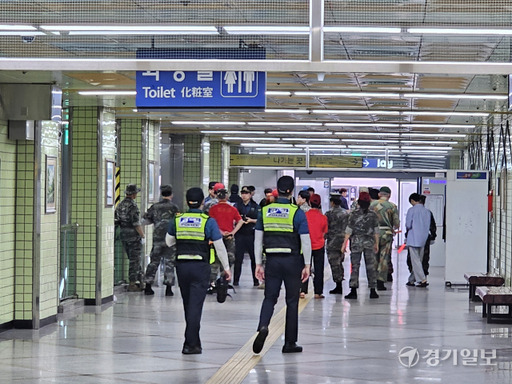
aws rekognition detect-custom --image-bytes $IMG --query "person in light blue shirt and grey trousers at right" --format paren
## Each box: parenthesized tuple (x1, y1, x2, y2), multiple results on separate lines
(405, 193, 431, 288)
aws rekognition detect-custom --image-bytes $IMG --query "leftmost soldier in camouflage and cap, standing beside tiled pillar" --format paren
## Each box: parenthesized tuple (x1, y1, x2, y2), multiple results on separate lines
(114, 184, 145, 292)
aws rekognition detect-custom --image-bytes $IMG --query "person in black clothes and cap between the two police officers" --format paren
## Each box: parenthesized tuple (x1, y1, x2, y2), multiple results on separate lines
(233, 186, 260, 287)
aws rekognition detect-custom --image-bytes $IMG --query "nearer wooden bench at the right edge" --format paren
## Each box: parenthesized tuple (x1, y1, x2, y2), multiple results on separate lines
(475, 287, 512, 324)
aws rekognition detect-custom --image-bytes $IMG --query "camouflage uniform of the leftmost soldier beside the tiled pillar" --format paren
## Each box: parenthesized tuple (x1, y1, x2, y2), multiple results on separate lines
(114, 197, 142, 283)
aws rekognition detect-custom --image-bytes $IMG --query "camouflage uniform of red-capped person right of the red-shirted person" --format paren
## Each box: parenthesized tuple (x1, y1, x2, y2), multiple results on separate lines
(345, 207, 379, 288)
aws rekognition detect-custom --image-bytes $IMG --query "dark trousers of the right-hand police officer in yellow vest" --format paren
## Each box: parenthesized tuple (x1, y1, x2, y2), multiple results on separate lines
(258, 254, 304, 343)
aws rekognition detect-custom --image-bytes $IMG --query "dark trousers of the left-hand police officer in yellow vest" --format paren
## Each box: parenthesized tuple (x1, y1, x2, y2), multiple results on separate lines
(176, 261, 210, 347)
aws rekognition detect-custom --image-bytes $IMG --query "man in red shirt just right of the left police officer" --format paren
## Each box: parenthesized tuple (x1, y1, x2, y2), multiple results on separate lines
(209, 183, 244, 283)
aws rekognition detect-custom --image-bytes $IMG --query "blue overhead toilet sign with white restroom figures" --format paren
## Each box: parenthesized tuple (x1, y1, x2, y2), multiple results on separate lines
(136, 49, 266, 110)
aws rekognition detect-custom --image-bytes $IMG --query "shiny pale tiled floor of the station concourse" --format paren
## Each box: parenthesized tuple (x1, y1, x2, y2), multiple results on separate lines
(0, 254, 512, 384)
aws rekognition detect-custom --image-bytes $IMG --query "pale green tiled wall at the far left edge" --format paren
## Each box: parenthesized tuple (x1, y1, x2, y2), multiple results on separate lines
(0, 121, 16, 327)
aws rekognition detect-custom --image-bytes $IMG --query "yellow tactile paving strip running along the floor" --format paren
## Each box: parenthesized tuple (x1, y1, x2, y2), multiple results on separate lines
(206, 293, 313, 384)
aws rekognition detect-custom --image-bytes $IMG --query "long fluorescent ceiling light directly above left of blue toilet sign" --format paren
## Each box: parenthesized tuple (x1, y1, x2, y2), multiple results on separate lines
(41, 24, 219, 35)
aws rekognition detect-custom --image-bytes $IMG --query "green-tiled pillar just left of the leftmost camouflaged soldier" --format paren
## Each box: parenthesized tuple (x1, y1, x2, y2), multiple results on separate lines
(71, 107, 116, 304)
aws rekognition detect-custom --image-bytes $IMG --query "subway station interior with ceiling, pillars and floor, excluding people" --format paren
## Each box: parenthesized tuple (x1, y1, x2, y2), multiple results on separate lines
(0, 0, 512, 384)
